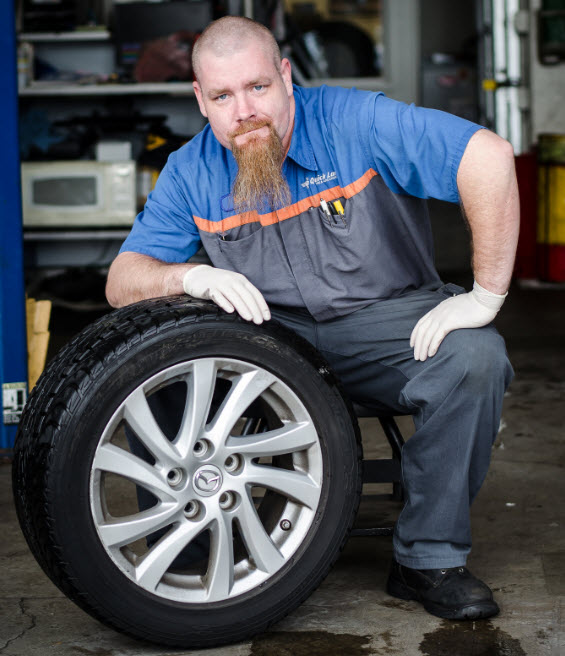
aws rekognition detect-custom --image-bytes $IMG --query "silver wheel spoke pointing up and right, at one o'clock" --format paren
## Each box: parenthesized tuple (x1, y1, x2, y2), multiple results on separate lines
(209, 370, 275, 443)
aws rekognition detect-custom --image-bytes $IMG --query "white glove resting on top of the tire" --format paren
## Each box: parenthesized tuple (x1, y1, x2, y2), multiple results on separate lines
(182, 264, 271, 323)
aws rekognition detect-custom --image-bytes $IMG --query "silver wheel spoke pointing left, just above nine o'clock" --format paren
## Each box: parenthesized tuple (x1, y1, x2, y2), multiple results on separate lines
(93, 444, 173, 501)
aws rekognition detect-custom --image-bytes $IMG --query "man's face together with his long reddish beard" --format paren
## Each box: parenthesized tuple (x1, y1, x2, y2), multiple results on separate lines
(194, 43, 294, 212)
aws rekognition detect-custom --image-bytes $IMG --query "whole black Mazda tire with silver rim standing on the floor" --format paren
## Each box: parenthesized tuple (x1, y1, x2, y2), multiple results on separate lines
(13, 296, 361, 649)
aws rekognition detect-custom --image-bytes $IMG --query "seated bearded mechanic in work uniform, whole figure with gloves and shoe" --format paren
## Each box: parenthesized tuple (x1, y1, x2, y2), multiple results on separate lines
(107, 17, 519, 619)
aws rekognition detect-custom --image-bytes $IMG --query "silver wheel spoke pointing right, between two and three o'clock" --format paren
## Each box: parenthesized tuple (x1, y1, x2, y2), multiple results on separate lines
(226, 421, 317, 458)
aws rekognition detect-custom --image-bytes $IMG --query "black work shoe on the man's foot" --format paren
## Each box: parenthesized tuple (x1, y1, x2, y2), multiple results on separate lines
(386, 560, 499, 620)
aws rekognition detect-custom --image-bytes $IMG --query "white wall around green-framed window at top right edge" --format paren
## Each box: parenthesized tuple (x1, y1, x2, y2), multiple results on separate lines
(530, 0, 565, 142)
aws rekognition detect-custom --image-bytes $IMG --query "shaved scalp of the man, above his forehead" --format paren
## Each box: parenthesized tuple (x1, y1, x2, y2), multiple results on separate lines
(192, 16, 281, 80)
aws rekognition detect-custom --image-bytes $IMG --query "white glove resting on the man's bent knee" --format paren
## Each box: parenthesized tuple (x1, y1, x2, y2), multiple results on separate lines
(410, 281, 508, 362)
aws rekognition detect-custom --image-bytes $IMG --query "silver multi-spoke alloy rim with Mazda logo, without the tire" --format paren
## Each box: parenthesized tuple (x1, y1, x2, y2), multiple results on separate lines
(90, 358, 323, 603)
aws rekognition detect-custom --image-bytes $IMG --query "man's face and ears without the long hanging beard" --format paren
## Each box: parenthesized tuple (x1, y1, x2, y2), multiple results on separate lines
(194, 42, 294, 151)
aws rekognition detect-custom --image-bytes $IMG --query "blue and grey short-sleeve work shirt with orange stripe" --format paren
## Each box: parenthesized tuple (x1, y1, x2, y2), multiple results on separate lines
(121, 86, 481, 320)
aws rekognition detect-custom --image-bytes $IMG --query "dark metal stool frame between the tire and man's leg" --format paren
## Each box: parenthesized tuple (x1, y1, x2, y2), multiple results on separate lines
(351, 403, 404, 537)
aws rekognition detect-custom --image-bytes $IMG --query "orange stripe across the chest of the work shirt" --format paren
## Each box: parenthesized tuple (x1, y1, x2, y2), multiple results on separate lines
(194, 169, 378, 233)
